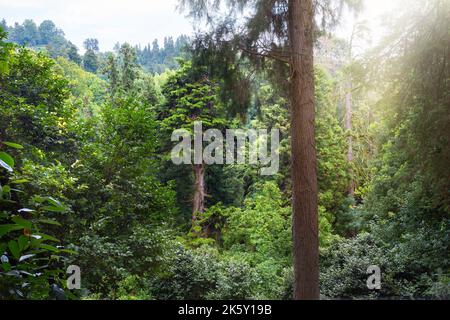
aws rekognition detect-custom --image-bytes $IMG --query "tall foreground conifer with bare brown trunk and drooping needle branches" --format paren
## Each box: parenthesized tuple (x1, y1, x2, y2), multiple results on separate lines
(181, 0, 359, 299)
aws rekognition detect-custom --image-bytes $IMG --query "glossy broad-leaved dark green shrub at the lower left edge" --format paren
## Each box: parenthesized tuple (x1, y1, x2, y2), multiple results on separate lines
(0, 142, 72, 299)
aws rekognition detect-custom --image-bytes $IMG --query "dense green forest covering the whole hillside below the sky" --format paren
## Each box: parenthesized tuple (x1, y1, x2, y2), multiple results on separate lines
(0, 0, 450, 300)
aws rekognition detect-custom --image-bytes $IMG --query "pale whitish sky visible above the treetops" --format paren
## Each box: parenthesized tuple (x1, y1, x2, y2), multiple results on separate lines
(0, 0, 399, 51)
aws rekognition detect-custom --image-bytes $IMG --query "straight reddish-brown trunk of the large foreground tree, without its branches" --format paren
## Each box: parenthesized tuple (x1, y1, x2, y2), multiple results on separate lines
(288, 0, 319, 300)
